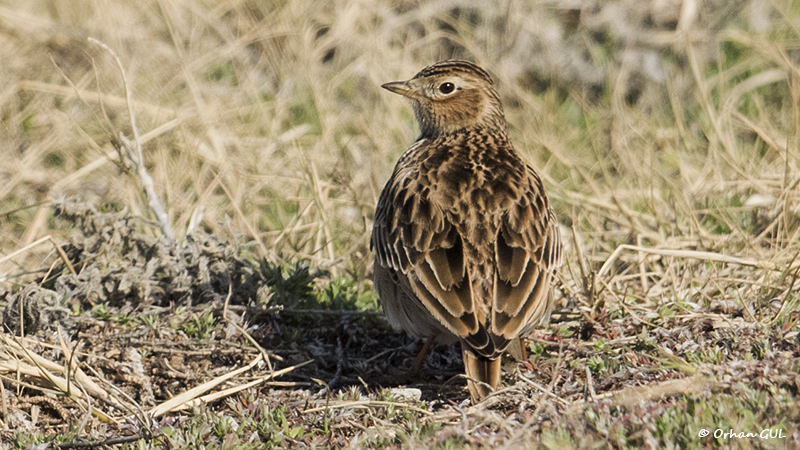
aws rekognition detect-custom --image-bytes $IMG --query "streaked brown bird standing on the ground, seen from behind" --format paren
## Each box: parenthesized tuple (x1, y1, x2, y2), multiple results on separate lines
(370, 59, 563, 403)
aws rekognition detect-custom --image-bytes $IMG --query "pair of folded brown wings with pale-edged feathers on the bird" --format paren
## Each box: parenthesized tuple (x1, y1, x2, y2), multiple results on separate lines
(372, 153, 561, 358)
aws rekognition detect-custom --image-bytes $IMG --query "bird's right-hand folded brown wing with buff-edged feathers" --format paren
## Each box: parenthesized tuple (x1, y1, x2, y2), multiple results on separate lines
(491, 167, 562, 342)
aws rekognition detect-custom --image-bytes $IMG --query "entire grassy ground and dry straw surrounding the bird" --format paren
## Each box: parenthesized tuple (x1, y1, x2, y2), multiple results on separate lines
(0, 0, 800, 449)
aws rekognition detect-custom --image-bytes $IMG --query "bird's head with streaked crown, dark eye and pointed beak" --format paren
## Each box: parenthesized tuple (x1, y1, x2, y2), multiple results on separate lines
(381, 59, 506, 136)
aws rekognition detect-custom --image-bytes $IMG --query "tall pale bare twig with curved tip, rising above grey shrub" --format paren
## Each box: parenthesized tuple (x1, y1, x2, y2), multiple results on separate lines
(89, 37, 175, 240)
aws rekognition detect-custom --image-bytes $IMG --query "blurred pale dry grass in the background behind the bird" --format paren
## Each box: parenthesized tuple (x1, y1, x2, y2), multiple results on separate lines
(0, 0, 800, 295)
